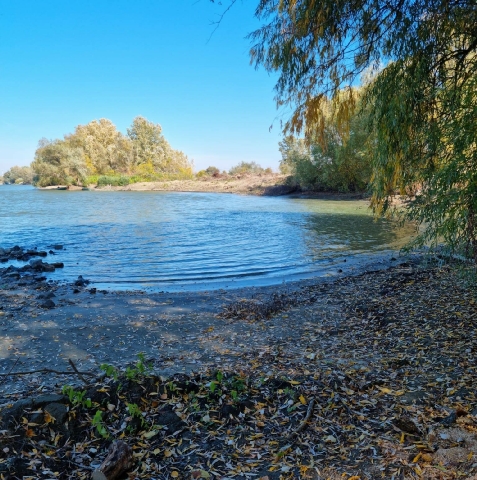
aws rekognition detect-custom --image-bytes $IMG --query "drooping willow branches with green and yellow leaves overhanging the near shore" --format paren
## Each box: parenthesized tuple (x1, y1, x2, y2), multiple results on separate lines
(233, 0, 477, 261)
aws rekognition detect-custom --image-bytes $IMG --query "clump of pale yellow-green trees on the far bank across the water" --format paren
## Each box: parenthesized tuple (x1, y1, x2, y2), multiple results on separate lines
(32, 117, 192, 186)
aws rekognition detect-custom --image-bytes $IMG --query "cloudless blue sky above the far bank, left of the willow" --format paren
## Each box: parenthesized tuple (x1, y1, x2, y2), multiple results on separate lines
(0, 0, 280, 173)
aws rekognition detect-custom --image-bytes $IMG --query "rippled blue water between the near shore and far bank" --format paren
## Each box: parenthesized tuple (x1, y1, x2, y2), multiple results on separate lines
(0, 185, 410, 291)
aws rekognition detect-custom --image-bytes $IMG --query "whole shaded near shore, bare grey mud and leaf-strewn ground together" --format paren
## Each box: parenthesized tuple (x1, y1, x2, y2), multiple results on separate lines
(0, 249, 477, 480)
